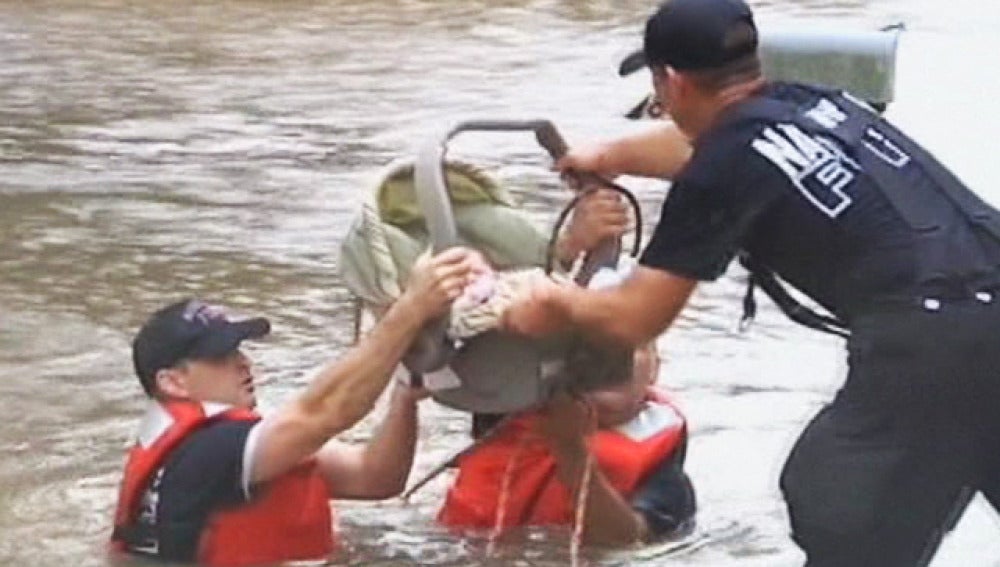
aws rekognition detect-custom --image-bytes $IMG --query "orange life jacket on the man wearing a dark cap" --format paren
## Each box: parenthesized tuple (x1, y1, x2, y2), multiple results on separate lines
(111, 401, 334, 567)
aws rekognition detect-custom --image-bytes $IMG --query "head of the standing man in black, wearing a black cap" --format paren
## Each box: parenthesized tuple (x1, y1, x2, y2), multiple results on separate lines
(643, 0, 763, 137)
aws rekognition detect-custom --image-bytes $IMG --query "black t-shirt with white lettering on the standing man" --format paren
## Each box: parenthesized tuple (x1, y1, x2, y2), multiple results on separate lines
(642, 83, 915, 316)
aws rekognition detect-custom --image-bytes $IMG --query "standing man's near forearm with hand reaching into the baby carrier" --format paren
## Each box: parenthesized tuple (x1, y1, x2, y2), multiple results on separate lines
(502, 266, 698, 347)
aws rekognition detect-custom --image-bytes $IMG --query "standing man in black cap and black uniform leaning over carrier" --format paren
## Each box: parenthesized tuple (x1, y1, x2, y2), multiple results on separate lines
(505, 0, 1000, 567)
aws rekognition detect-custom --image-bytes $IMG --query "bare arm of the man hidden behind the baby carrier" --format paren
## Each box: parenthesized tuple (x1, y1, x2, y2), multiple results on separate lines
(540, 392, 649, 545)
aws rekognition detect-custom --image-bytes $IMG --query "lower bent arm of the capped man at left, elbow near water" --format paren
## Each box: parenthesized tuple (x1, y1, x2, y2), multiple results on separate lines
(317, 383, 426, 499)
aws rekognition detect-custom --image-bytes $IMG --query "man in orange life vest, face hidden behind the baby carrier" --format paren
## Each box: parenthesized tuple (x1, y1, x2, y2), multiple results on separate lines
(438, 344, 695, 545)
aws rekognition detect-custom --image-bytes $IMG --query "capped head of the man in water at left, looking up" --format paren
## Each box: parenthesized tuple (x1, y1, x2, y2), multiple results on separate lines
(132, 299, 271, 408)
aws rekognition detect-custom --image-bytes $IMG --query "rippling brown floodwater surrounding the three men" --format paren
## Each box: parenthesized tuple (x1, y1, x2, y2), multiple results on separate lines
(0, 0, 1000, 567)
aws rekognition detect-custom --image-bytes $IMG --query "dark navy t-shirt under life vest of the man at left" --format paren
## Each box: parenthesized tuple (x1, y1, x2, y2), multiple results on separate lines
(130, 421, 258, 562)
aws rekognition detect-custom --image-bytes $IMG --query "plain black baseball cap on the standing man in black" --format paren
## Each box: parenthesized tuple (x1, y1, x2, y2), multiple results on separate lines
(618, 0, 758, 76)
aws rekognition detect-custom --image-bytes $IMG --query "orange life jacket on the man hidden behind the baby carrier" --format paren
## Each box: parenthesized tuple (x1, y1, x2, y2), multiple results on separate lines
(438, 389, 686, 528)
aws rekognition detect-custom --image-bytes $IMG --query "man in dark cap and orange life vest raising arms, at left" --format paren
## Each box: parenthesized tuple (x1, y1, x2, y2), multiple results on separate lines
(112, 248, 483, 566)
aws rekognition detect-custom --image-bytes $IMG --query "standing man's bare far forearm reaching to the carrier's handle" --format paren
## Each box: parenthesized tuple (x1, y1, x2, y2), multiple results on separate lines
(556, 122, 691, 179)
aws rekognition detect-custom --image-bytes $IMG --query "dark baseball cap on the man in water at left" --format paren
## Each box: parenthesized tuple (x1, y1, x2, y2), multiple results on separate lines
(132, 299, 271, 395)
